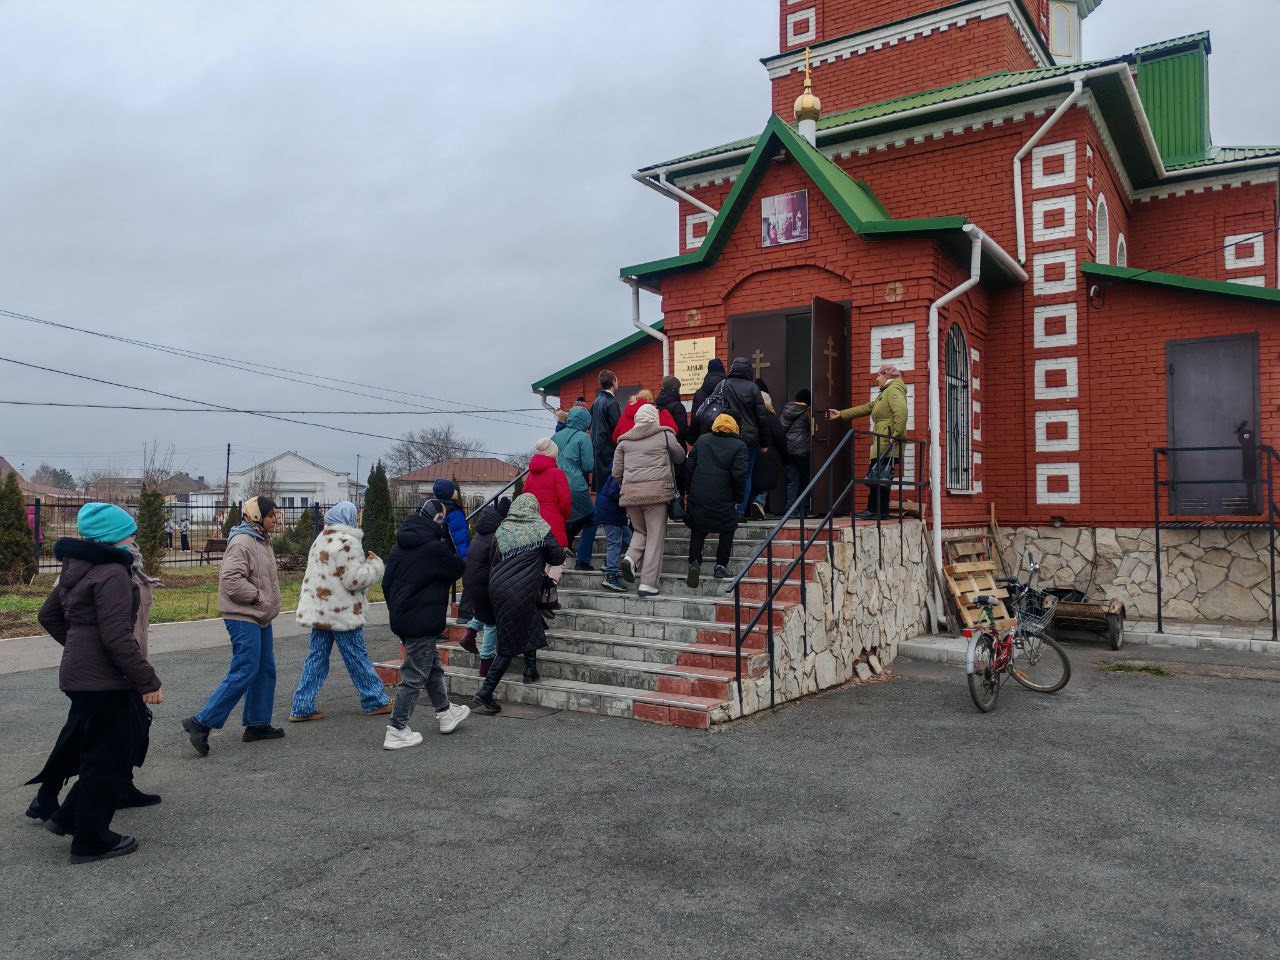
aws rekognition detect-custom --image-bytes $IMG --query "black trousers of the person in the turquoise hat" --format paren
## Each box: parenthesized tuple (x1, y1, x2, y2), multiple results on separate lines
(54, 690, 141, 850)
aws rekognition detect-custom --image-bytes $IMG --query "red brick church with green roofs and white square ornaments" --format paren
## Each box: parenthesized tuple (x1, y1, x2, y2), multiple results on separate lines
(534, 0, 1280, 616)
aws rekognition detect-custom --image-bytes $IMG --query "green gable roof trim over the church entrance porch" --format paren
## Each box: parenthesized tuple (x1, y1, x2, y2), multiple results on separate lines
(620, 115, 966, 282)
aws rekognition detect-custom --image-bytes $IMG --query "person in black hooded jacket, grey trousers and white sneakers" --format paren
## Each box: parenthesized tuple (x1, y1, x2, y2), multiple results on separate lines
(383, 498, 471, 750)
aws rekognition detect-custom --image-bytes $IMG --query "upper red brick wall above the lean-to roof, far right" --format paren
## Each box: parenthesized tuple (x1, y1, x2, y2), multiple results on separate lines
(1126, 174, 1277, 287)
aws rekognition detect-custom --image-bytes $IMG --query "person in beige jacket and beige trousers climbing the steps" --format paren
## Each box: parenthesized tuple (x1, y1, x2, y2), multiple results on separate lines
(613, 403, 685, 596)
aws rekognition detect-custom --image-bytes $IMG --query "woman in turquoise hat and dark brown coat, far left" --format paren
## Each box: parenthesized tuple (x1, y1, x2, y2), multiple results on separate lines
(32, 503, 161, 863)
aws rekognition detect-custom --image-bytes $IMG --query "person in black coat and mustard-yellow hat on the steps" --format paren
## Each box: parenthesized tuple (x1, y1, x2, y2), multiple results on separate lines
(685, 413, 746, 586)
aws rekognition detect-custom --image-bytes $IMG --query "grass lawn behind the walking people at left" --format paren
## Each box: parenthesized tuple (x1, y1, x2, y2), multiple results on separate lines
(0, 566, 383, 639)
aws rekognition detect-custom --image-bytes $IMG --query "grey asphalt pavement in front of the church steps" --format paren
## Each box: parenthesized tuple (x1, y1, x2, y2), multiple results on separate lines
(0, 625, 1280, 960)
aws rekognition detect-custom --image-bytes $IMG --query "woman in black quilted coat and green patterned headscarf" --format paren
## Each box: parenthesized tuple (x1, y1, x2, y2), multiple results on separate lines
(475, 493, 564, 714)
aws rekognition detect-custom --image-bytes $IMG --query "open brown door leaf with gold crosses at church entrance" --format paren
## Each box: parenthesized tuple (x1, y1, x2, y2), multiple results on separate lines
(809, 297, 861, 513)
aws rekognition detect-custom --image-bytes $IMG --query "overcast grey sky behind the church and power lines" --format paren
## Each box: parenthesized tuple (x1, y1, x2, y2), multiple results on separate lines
(0, 0, 1280, 483)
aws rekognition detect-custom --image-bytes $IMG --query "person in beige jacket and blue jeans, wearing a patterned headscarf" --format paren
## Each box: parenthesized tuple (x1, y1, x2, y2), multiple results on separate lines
(182, 497, 284, 756)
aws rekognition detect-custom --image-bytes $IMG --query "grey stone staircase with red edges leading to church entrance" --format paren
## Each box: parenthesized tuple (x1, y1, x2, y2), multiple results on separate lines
(376, 522, 827, 730)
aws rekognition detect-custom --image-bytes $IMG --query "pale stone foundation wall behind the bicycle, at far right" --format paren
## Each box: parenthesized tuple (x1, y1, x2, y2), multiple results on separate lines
(1000, 527, 1271, 622)
